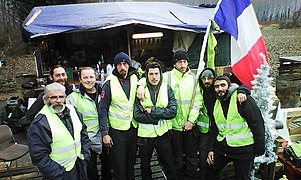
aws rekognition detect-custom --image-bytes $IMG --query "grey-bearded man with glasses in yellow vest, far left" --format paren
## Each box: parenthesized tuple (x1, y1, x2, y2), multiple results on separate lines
(27, 83, 91, 180)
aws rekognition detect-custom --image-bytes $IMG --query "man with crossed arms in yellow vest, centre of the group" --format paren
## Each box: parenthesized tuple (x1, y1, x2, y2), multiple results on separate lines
(134, 62, 177, 180)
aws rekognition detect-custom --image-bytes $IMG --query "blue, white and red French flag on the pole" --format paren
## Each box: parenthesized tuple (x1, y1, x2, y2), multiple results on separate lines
(214, 0, 267, 89)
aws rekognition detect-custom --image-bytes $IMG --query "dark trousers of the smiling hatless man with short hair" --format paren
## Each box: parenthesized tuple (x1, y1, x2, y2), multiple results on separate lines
(88, 146, 112, 180)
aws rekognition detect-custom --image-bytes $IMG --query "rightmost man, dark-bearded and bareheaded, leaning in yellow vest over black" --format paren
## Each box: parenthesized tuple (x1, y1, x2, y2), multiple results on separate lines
(207, 75, 265, 180)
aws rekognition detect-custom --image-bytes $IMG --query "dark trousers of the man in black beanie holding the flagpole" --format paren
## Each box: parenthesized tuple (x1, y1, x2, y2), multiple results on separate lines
(171, 126, 199, 179)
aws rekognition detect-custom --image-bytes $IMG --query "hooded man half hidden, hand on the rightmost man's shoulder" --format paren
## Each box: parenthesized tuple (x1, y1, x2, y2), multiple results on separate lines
(188, 68, 250, 179)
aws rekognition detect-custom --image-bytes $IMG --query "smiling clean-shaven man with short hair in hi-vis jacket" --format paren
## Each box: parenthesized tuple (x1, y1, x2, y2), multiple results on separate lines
(66, 67, 111, 180)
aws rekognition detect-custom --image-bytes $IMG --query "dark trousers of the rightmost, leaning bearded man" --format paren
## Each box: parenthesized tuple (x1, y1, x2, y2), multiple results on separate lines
(206, 153, 253, 180)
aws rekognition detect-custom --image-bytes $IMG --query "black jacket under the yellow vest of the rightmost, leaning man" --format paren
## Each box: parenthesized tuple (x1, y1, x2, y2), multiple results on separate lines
(209, 92, 265, 160)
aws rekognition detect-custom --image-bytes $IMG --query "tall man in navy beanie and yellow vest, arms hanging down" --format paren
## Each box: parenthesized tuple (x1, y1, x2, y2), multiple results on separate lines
(99, 52, 138, 180)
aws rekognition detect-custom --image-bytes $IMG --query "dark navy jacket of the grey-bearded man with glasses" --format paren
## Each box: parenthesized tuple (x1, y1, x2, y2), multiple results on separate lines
(27, 106, 91, 179)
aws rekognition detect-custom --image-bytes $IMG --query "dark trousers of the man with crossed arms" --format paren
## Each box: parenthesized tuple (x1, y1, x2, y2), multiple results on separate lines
(138, 133, 177, 180)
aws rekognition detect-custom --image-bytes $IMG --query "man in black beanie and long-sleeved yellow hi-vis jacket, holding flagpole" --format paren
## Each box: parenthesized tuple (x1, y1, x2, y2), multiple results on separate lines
(163, 50, 198, 179)
